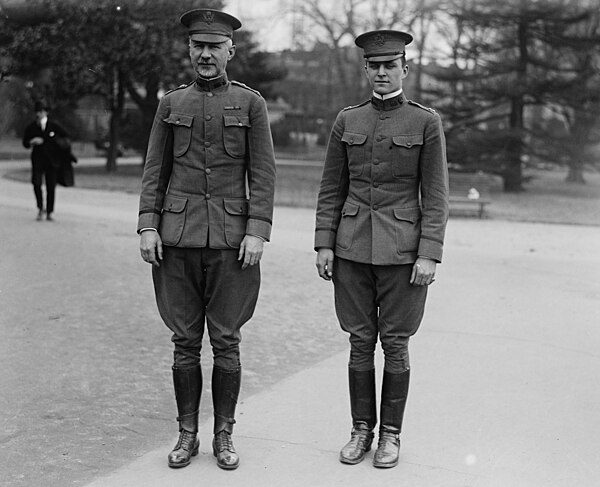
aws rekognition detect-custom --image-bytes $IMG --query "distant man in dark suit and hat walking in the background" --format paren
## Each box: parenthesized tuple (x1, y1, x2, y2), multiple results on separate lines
(23, 101, 68, 221)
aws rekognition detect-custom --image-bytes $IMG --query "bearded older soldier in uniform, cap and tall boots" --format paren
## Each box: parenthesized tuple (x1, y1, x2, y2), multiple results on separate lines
(138, 9, 275, 469)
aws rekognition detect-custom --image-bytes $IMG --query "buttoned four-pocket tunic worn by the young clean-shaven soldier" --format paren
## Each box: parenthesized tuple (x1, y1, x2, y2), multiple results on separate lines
(315, 94, 448, 265)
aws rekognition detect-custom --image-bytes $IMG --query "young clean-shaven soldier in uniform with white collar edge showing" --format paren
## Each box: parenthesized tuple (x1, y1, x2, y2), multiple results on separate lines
(315, 30, 448, 468)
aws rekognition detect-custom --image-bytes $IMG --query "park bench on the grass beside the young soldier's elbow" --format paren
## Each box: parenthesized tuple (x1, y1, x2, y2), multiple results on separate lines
(449, 172, 492, 218)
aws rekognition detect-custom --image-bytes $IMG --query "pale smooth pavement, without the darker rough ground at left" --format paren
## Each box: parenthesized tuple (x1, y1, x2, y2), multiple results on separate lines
(0, 158, 600, 487)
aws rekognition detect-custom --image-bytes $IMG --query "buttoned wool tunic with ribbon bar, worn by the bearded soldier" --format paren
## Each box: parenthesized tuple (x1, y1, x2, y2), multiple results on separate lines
(138, 77, 275, 249)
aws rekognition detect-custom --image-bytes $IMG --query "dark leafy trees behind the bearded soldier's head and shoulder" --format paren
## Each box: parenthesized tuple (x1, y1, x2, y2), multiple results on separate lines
(0, 0, 283, 170)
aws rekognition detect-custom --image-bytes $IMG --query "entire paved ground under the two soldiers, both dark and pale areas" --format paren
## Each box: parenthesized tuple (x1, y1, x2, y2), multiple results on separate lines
(0, 158, 600, 487)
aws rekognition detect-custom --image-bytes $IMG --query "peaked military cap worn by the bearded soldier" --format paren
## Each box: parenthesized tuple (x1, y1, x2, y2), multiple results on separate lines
(179, 8, 242, 44)
